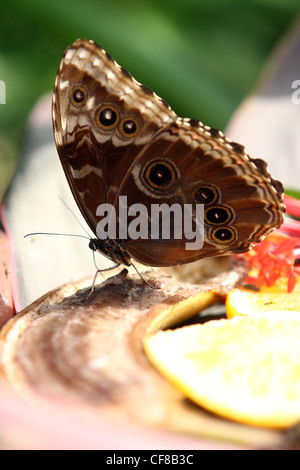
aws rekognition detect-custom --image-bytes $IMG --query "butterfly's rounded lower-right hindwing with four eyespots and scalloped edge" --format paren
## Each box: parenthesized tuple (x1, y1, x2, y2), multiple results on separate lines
(114, 118, 284, 266)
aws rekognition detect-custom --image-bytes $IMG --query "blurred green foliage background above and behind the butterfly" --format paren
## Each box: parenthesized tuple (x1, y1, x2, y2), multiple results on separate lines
(0, 0, 300, 197)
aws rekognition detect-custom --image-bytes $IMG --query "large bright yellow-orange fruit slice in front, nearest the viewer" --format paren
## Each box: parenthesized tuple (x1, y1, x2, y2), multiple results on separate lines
(144, 311, 300, 428)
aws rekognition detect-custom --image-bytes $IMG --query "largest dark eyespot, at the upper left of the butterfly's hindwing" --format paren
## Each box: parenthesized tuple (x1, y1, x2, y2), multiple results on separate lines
(144, 161, 176, 189)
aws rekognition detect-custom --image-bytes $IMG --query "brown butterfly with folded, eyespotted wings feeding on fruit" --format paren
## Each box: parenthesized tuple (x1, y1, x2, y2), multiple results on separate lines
(53, 39, 284, 266)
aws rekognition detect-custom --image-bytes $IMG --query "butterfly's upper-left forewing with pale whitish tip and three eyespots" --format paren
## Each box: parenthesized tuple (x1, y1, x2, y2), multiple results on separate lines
(52, 39, 177, 233)
